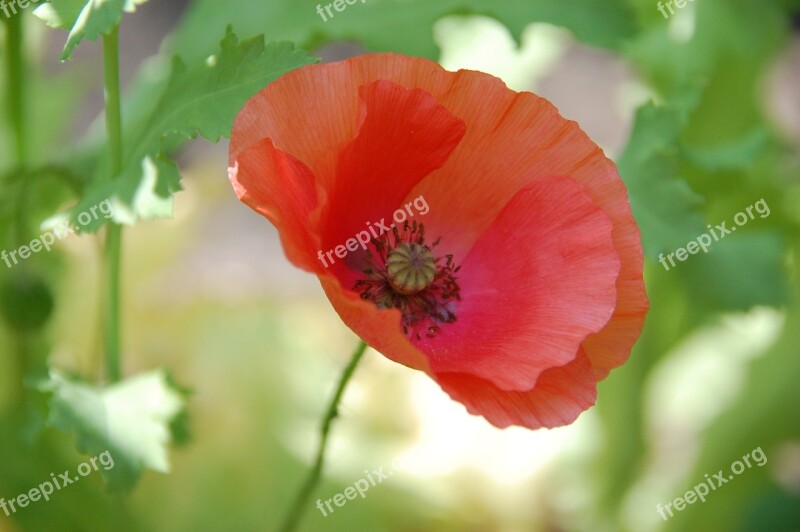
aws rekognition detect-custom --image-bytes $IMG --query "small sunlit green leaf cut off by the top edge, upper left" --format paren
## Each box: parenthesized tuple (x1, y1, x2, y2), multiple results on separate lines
(34, 0, 147, 61)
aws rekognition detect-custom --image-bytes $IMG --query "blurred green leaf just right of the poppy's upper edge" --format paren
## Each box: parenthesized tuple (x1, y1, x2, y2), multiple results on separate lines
(619, 98, 706, 260)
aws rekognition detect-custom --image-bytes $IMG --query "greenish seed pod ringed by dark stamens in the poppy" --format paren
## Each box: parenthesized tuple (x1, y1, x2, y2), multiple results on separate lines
(353, 222, 461, 340)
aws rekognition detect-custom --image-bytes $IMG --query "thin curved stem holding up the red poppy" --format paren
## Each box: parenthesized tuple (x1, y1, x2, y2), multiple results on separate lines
(280, 342, 367, 532)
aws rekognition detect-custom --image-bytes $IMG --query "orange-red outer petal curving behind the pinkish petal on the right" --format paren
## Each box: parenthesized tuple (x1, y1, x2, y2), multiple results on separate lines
(409, 71, 649, 378)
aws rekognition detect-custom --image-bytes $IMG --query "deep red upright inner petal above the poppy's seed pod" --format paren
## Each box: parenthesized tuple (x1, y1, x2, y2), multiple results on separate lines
(320, 81, 465, 287)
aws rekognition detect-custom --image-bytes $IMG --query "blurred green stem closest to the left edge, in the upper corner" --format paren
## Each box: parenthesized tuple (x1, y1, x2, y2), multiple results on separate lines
(6, 16, 28, 167)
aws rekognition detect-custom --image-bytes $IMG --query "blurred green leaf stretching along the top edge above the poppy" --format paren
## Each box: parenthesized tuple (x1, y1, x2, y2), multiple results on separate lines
(173, 0, 636, 65)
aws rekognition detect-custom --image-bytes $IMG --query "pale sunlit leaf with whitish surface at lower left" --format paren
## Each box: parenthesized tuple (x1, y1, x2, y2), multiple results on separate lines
(40, 370, 185, 491)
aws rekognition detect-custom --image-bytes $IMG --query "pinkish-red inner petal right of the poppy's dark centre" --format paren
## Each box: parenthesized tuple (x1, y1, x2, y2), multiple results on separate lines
(416, 177, 620, 390)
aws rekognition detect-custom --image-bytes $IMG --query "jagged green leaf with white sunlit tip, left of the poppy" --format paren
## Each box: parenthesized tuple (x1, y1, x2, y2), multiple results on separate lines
(72, 28, 316, 231)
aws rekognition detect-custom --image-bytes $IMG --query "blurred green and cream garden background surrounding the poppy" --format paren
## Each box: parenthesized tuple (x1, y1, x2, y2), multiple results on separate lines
(0, 0, 800, 532)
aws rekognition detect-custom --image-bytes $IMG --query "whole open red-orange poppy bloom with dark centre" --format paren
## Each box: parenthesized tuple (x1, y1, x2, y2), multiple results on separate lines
(229, 54, 648, 428)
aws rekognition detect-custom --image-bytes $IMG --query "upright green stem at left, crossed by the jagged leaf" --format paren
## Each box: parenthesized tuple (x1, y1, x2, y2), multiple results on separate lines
(103, 27, 122, 382)
